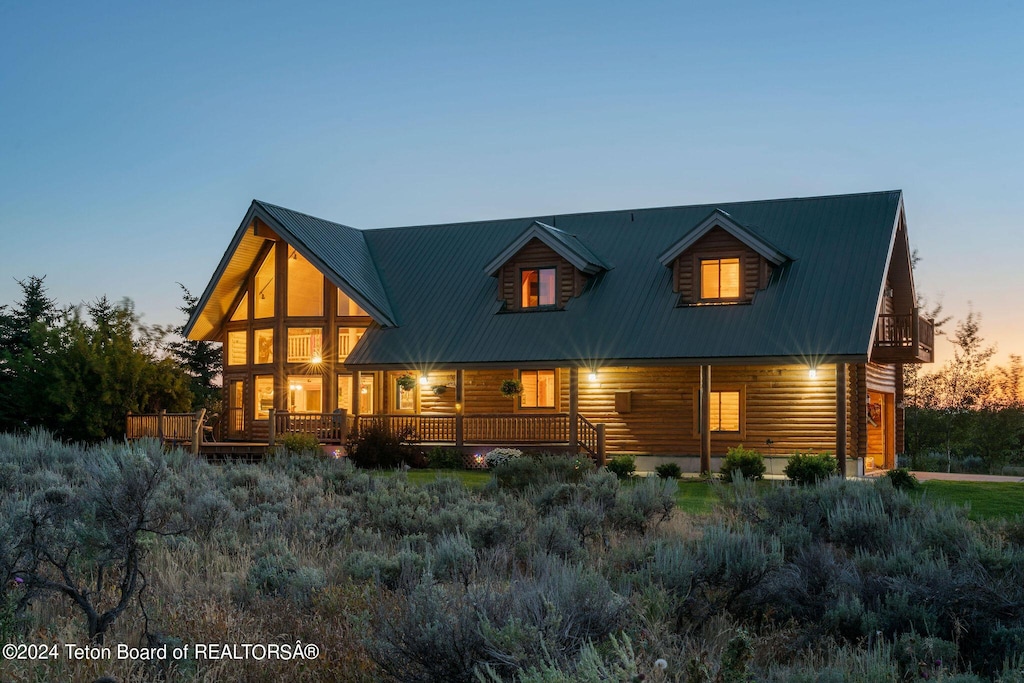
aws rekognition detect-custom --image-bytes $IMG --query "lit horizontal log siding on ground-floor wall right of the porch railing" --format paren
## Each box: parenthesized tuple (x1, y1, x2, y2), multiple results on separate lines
(580, 366, 836, 456)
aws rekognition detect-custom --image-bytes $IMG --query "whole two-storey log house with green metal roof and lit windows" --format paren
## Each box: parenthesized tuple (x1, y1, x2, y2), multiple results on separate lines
(185, 190, 934, 473)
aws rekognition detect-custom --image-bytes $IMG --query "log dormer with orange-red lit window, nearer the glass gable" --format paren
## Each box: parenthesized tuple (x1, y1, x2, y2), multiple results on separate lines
(484, 220, 609, 311)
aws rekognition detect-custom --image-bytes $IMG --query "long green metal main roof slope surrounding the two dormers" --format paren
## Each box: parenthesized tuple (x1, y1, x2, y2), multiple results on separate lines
(346, 190, 902, 368)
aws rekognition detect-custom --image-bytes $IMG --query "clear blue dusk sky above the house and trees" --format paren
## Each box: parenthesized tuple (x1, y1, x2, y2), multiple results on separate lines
(0, 0, 1024, 359)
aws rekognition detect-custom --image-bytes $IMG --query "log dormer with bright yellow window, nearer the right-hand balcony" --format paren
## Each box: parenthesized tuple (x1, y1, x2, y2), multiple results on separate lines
(658, 209, 790, 306)
